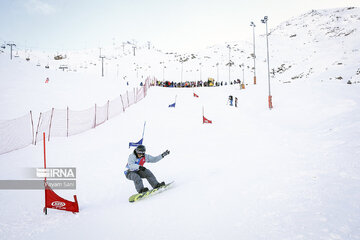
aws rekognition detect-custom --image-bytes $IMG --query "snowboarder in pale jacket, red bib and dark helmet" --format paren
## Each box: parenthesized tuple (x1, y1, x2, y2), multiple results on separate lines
(124, 145, 170, 193)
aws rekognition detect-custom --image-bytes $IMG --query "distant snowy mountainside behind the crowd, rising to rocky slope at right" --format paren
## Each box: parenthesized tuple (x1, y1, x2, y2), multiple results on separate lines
(3, 7, 360, 89)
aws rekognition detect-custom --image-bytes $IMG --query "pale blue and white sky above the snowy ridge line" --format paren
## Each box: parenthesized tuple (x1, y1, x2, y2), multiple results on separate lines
(0, 0, 360, 50)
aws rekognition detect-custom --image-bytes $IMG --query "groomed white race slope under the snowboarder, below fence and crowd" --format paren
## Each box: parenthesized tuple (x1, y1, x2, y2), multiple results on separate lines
(0, 81, 360, 239)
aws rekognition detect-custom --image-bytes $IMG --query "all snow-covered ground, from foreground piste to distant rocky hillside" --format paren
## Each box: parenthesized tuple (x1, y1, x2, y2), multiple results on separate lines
(0, 6, 360, 240)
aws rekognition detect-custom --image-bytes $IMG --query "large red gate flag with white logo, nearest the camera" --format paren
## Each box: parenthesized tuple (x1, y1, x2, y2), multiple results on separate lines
(45, 183, 79, 213)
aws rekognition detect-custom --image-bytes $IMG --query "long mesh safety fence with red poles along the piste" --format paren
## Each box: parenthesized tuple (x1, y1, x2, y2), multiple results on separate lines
(0, 78, 150, 154)
